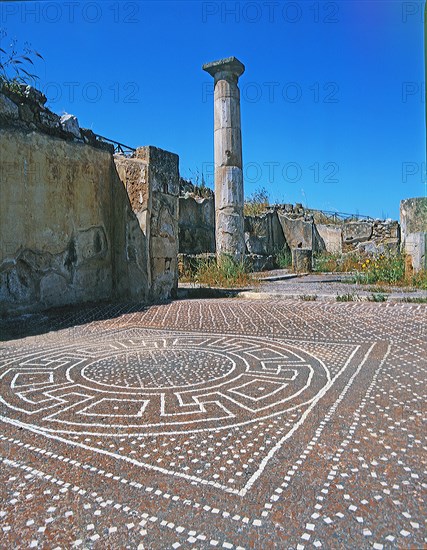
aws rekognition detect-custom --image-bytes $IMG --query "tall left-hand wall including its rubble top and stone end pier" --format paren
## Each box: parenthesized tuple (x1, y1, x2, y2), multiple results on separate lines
(0, 87, 179, 314)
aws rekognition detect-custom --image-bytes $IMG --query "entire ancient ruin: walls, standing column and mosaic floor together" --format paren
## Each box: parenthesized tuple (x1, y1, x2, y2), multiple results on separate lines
(0, 58, 427, 550)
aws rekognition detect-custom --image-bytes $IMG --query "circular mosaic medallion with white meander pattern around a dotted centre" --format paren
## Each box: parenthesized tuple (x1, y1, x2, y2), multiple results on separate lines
(2, 330, 330, 435)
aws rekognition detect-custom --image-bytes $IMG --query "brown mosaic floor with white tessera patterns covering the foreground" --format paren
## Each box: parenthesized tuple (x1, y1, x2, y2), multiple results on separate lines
(0, 299, 427, 549)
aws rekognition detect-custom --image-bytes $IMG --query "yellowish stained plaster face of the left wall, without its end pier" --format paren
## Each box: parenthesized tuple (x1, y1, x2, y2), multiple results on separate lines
(0, 128, 147, 312)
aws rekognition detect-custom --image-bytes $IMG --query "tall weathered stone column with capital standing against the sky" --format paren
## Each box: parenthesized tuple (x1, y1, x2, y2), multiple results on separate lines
(203, 57, 245, 260)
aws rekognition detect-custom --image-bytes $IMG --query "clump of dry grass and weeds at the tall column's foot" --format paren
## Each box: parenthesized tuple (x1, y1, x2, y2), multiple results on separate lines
(181, 255, 256, 288)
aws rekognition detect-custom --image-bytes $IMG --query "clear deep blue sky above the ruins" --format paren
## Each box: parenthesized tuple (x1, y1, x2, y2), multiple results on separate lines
(0, 0, 426, 218)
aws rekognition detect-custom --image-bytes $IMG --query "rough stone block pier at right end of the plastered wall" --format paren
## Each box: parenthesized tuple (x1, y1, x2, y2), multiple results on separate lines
(114, 146, 179, 299)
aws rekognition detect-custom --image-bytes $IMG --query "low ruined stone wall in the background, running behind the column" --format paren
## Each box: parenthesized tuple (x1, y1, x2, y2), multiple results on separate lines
(179, 201, 400, 269)
